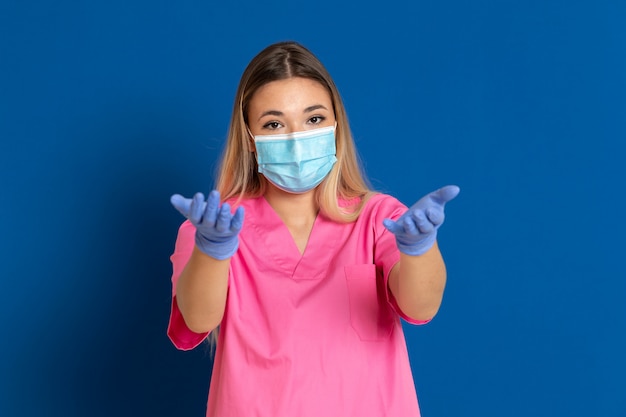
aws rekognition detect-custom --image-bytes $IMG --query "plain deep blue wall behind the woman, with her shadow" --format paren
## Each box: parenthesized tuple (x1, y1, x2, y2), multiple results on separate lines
(0, 0, 626, 417)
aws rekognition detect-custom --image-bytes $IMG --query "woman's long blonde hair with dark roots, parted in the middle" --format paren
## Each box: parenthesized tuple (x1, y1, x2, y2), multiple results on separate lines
(216, 42, 373, 222)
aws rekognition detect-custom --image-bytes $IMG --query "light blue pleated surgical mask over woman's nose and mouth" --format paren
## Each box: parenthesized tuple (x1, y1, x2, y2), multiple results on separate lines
(254, 124, 337, 193)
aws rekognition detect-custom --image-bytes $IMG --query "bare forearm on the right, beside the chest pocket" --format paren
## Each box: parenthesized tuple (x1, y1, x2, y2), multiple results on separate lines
(389, 242, 446, 320)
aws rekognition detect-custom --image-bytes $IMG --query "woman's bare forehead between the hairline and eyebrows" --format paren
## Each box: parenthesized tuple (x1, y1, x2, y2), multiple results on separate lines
(250, 77, 332, 111)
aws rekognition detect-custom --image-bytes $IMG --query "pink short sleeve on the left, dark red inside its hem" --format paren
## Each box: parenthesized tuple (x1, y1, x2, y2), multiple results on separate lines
(167, 220, 208, 350)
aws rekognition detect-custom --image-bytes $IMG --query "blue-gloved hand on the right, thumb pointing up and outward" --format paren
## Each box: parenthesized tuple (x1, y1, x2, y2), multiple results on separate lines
(383, 185, 460, 255)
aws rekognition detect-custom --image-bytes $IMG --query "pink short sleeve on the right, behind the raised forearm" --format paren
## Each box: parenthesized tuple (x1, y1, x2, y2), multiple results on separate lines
(372, 195, 430, 324)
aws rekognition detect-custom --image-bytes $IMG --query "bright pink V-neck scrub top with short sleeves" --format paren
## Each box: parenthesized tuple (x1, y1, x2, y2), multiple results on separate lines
(168, 194, 425, 417)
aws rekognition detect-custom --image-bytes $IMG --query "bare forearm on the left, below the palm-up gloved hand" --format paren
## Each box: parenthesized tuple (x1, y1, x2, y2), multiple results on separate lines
(176, 247, 230, 333)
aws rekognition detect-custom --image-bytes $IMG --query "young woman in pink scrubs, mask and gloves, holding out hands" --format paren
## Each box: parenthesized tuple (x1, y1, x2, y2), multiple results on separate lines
(168, 42, 459, 417)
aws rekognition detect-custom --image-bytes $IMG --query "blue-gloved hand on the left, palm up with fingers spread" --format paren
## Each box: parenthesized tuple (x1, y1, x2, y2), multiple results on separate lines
(170, 190, 244, 260)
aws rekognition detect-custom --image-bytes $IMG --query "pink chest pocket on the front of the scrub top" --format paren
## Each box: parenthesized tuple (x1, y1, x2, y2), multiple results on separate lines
(344, 264, 395, 342)
